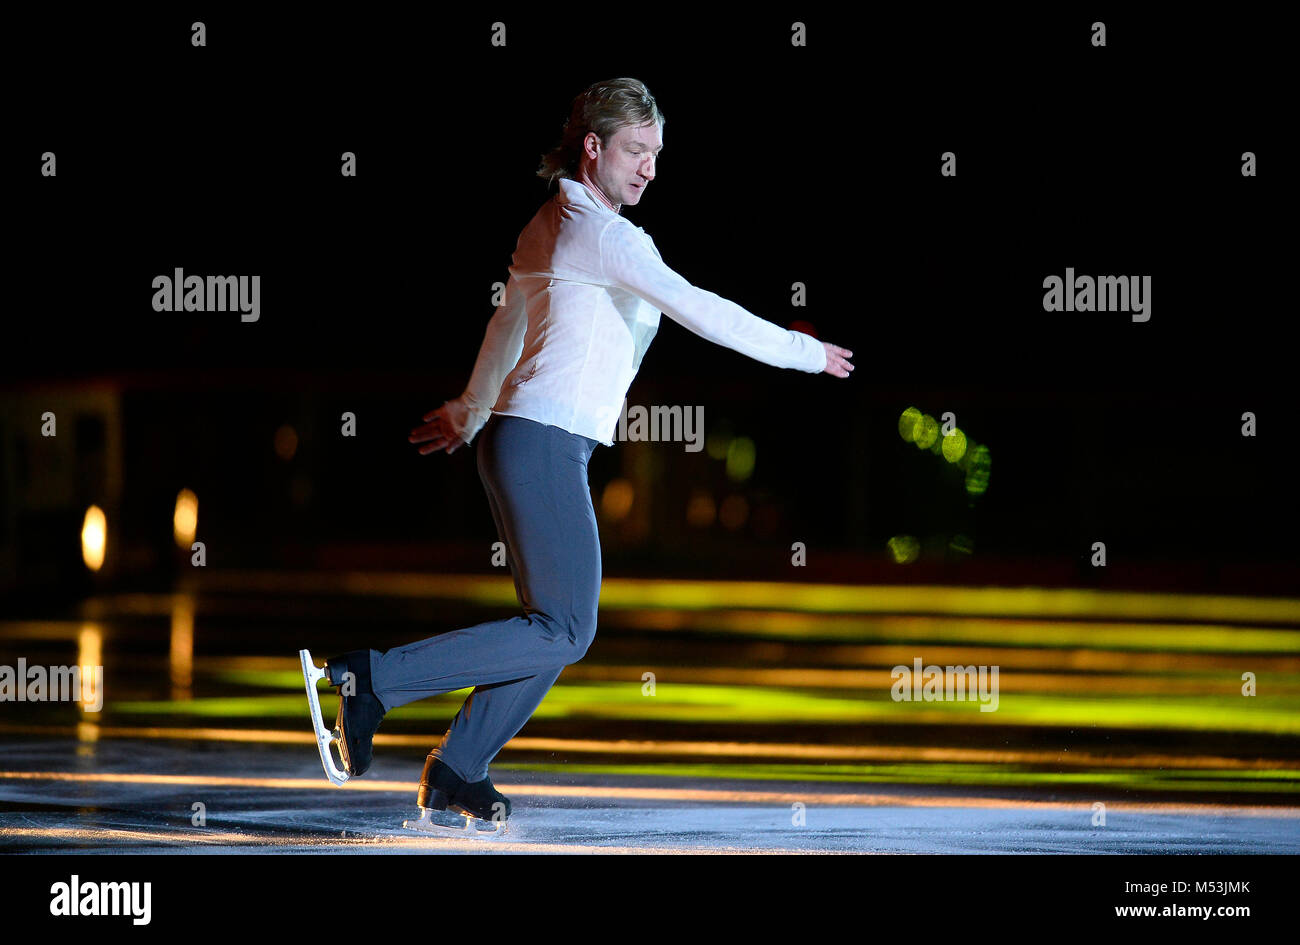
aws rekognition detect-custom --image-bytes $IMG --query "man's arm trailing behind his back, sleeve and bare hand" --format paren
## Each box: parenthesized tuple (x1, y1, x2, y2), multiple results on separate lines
(410, 274, 528, 455)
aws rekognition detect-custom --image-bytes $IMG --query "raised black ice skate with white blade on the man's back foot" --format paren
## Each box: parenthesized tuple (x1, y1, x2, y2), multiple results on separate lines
(298, 650, 385, 784)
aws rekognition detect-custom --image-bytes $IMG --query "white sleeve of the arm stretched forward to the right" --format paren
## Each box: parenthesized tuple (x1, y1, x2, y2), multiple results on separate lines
(601, 220, 826, 373)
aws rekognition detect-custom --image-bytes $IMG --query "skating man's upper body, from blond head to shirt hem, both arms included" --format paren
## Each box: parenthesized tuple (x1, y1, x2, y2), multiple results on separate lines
(423, 79, 853, 454)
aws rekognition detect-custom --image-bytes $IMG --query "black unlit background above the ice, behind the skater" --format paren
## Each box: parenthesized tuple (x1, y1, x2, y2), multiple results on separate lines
(0, 6, 1300, 593)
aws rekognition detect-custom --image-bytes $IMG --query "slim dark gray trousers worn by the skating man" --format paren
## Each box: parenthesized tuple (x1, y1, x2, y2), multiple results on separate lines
(371, 413, 601, 781)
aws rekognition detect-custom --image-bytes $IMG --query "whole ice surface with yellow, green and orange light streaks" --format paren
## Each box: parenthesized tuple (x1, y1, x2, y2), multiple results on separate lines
(0, 575, 1300, 854)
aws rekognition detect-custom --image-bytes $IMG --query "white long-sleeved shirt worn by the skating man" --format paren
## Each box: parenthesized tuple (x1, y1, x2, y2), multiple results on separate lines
(447, 177, 826, 446)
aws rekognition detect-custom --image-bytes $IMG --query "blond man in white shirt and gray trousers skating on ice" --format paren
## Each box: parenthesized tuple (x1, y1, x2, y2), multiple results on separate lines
(317, 78, 853, 819)
